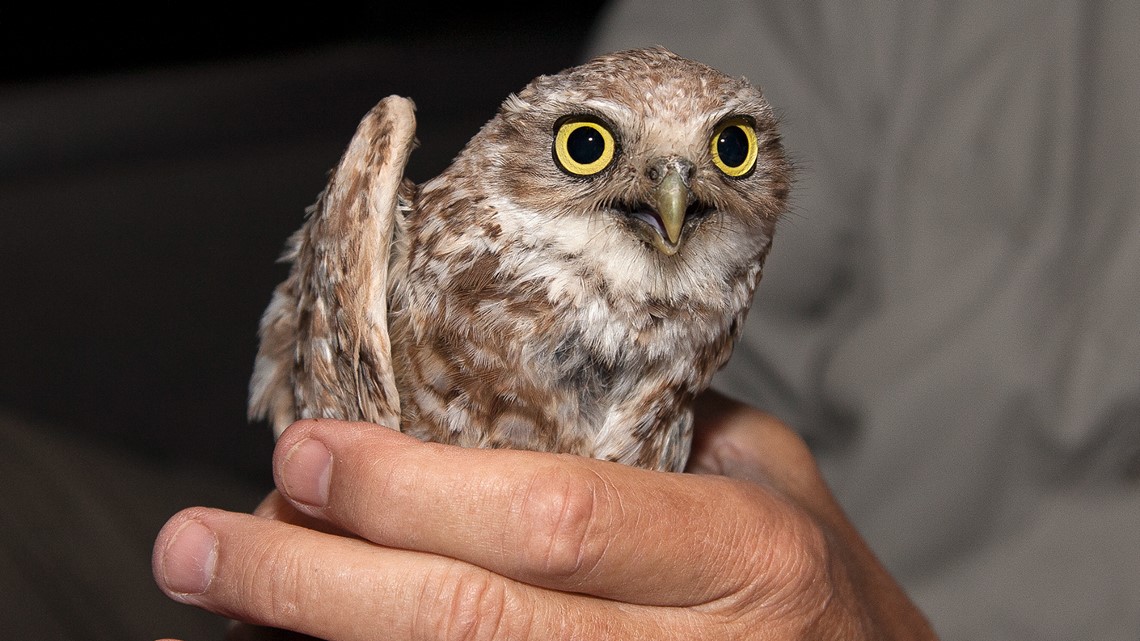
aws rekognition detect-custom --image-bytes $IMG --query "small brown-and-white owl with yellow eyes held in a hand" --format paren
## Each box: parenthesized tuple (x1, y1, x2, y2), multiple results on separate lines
(250, 48, 791, 471)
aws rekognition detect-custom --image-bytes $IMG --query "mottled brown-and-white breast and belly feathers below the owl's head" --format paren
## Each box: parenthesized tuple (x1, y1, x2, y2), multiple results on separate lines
(389, 207, 751, 457)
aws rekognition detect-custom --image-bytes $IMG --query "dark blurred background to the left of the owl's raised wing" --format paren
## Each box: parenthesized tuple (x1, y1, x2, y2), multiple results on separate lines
(0, 2, 615, 482)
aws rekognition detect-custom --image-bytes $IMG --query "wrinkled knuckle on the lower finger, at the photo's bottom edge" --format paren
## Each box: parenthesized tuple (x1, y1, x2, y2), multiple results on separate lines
(413, 562, 524, 641)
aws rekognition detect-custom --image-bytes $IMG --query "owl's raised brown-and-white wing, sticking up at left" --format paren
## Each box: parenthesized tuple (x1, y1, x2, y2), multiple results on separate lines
(250, 96, 415, 436)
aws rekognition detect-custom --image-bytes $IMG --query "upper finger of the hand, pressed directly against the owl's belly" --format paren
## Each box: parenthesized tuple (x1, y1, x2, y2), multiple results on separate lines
(274, 421, 822, 606)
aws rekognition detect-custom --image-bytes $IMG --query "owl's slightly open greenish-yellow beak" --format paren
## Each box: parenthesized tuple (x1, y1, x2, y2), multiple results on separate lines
(625, 159, 706, 255)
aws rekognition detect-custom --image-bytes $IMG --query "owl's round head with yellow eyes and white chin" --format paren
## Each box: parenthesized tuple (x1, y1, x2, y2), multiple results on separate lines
(437, 49, 790, 294)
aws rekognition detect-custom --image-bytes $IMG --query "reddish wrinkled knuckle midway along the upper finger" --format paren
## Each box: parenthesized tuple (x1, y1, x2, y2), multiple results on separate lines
(516, 460, 608, 578)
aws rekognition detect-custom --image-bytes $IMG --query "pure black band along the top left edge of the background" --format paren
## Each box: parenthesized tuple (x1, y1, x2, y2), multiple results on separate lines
(0, 6, 604, 82)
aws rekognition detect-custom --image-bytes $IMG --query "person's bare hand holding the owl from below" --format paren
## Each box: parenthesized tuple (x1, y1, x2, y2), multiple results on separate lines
(153, 393, 935, 641)
